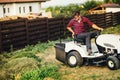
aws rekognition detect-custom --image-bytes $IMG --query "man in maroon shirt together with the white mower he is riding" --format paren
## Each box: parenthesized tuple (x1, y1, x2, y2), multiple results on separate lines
(55, 12, 120, 70)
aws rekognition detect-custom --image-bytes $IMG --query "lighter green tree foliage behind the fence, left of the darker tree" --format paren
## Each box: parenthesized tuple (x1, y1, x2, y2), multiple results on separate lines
(46, 4, 81, 17)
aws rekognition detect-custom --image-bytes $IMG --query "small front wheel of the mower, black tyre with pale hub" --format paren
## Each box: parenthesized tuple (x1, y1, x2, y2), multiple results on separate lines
(107, 56, 120, 70)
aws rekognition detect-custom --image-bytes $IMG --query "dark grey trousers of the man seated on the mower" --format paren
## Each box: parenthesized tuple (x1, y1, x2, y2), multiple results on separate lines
(75, 32, 97, 50)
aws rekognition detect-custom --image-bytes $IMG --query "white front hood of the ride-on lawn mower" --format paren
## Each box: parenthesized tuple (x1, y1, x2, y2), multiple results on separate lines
(96, 34, 120, 53)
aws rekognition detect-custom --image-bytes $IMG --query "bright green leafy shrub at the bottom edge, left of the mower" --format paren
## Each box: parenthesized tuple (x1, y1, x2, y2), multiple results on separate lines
(21, 64, 61, 80)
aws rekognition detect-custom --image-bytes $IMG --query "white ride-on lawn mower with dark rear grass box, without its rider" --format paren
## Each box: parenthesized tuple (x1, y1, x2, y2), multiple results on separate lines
(55, 31, 120, 70)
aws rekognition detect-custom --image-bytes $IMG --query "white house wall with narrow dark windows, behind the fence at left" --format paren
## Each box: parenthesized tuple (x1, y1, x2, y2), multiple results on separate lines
(0, 2, 41, 17)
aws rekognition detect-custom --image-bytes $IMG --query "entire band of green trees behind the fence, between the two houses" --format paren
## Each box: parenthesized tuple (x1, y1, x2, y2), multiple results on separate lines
(46, 0, 103, 17)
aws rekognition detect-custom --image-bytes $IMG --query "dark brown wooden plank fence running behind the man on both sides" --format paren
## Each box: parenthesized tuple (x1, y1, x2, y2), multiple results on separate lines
(0, 12, 120, 51)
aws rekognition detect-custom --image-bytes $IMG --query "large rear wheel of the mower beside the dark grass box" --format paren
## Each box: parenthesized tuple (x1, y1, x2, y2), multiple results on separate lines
(67, 51, 83, 67)
